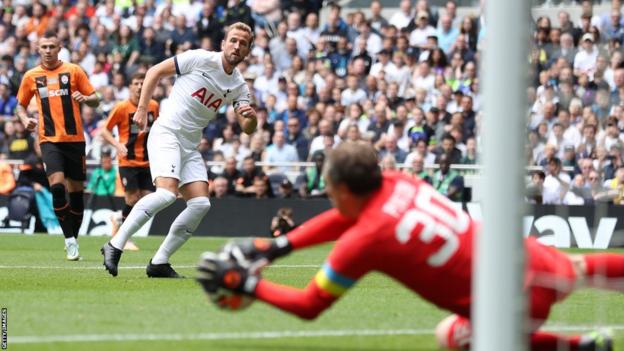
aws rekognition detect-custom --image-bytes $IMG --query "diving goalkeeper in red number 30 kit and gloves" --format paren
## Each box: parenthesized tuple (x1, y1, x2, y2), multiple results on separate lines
(198, 143, 624, 350)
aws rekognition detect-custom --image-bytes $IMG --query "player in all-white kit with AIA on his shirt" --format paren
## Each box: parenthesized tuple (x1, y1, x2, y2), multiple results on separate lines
(101, 22, 257, 278)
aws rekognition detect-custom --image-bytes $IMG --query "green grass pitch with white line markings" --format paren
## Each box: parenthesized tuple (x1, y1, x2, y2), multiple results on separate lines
(0, 235, 624, 351)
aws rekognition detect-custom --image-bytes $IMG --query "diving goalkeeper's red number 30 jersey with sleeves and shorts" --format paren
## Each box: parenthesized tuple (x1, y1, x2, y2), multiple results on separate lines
(256, 173, 574, 318)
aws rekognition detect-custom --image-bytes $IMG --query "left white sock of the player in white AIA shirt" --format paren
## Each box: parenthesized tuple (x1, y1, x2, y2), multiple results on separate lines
(110, 188, 176, 250)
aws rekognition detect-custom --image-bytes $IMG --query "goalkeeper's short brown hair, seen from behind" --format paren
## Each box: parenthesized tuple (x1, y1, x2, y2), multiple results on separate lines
(324, 142, 382, 196)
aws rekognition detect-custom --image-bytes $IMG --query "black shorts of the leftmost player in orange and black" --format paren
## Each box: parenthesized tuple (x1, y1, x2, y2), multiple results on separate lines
(41, 142, 87, 180)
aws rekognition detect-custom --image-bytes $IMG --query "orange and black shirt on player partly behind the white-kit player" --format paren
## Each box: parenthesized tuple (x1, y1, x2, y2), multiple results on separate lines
(106, 99, 158, 167)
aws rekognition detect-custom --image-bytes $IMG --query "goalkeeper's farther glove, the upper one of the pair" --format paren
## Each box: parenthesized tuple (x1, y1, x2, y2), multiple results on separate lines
(221, 236, 292, 271)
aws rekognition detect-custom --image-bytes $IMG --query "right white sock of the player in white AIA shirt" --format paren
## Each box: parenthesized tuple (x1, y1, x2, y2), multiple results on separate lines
(152, 196, 210, 264)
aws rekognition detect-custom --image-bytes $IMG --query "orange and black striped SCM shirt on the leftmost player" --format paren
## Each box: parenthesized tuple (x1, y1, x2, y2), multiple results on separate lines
(17, 62, 95, 143)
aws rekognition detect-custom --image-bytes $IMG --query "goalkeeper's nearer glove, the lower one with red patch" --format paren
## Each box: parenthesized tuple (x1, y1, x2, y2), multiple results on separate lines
(197, 252, 260, 296)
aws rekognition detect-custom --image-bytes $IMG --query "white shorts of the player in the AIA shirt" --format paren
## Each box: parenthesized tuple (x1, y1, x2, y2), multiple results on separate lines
(147, 123, 208, 187)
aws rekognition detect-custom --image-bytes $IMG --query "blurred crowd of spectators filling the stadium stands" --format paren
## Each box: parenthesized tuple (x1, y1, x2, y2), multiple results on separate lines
(0, 0, 624, 204)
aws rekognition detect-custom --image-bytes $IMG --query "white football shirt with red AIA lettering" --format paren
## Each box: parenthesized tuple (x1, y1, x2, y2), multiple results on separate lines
(156, 49, 251, 147)
